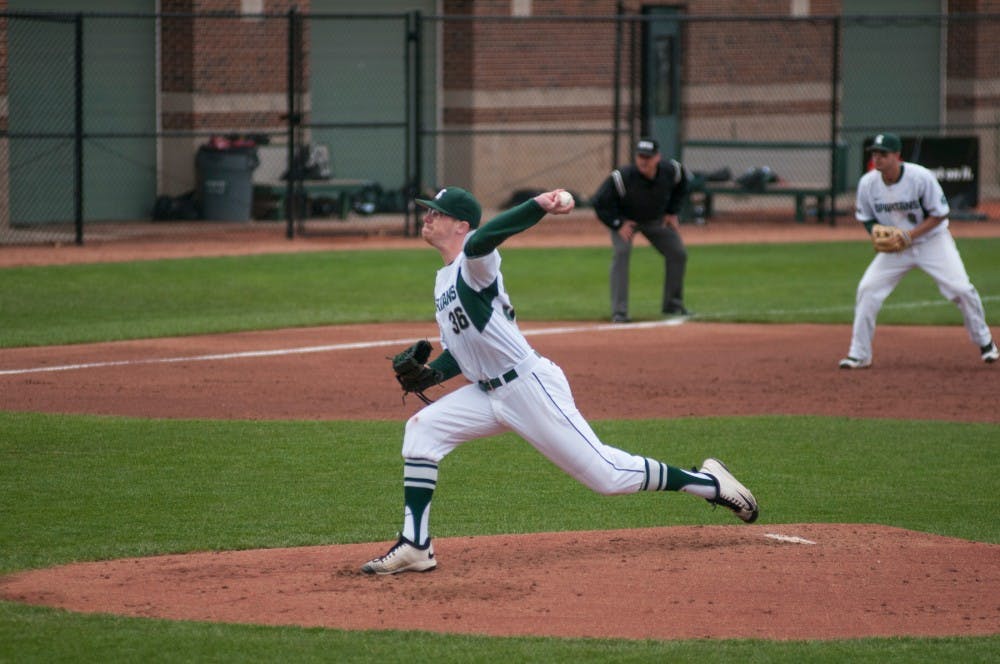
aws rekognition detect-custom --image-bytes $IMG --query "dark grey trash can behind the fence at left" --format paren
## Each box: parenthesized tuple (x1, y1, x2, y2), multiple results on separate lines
(195, 145, 260, 221)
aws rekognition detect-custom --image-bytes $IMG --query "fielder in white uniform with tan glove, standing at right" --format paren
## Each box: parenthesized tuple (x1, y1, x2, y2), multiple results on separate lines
(840, 133, 1000, 369)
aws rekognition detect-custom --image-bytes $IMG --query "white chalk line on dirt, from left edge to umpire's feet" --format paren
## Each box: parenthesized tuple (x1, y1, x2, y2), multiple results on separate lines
(0, 317, 687, 376)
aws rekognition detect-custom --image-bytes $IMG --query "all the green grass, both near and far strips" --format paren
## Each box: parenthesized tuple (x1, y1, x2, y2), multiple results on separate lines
(0, 240, 1000, 662)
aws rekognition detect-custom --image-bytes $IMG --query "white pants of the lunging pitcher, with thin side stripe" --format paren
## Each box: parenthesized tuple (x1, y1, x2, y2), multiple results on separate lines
(403, 356, 646, 495)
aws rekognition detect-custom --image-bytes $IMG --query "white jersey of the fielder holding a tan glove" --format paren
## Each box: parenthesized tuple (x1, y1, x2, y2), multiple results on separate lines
(854, 161, 951, 244)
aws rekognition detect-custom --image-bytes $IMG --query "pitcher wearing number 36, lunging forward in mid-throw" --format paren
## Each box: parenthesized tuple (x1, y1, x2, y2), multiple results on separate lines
(361, 187, 758, 574)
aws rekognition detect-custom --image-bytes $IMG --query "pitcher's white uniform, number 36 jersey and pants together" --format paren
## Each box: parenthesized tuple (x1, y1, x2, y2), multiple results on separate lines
(412, 235, 652, 494)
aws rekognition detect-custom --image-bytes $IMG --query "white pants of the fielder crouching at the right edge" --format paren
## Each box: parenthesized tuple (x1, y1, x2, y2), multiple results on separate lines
(848, 232, 992, 360)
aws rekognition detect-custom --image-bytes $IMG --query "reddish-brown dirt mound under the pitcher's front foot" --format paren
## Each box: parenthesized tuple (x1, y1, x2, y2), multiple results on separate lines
(0, 524, 1000, 639)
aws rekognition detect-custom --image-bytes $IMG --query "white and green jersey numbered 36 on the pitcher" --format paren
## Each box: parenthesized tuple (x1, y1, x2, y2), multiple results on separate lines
(434, 235, 532, 382)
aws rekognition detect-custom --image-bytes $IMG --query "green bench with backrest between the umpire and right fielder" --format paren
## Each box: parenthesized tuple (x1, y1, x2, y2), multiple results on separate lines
(679, 140, 847, 223)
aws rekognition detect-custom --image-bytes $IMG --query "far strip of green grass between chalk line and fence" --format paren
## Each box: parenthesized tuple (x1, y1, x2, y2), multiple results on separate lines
(0, 239, 1000, 348)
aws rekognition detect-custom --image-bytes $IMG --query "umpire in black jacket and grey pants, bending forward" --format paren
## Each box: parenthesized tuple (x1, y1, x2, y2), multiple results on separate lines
(591, 138, 690, 323)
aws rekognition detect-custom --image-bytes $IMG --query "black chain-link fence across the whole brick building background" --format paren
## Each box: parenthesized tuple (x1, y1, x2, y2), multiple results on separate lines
(0, 10, 1000, 244)
